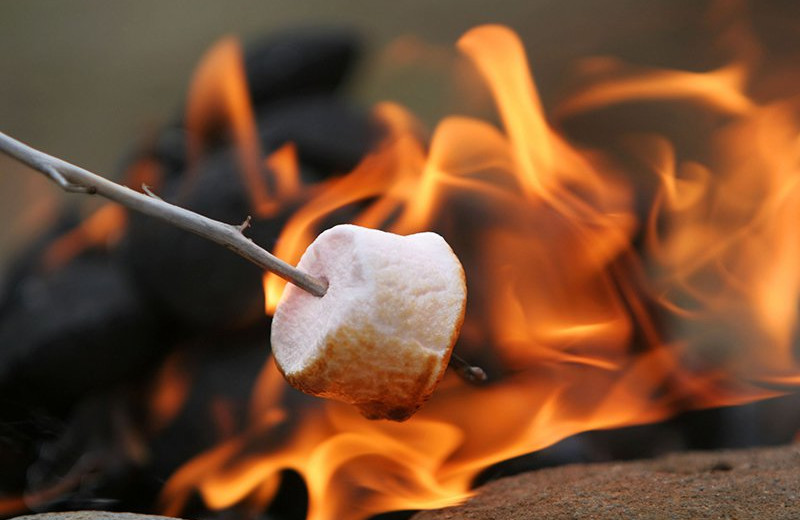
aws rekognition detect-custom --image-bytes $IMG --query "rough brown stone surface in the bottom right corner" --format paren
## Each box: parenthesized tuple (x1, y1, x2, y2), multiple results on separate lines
(413, 445, 800, 520)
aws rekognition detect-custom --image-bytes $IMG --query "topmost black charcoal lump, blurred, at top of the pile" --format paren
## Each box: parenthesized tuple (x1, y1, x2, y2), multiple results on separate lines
(245, 28, 360, 107)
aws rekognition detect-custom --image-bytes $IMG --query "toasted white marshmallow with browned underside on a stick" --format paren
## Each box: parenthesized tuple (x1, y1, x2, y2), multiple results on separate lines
(271, 225, 467, 421)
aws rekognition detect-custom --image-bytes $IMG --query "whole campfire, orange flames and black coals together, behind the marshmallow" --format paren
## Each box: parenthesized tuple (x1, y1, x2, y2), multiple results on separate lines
(0, 4, 800, 520)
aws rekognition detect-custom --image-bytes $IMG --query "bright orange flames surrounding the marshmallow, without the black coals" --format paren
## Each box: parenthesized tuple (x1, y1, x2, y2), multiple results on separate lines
(159, 14, 800, 520)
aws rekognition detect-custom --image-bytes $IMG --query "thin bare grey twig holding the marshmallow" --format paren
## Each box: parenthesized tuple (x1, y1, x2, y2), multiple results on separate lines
(0, 132, 328, 296)
